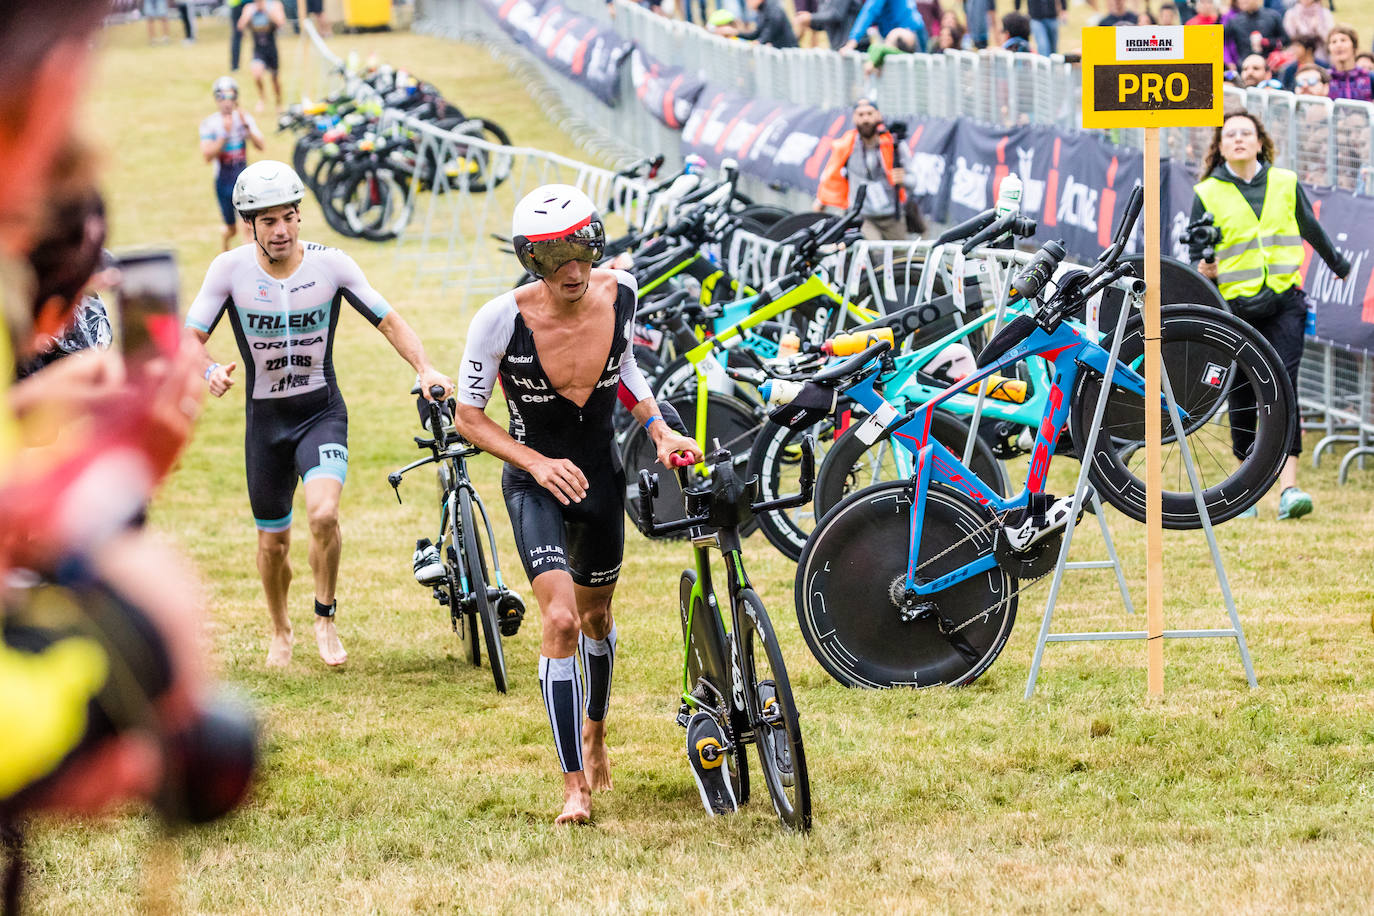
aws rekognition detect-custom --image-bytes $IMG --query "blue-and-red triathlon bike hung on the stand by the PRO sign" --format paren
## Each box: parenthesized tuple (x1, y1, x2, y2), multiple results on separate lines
(796, 188, 1294, 687)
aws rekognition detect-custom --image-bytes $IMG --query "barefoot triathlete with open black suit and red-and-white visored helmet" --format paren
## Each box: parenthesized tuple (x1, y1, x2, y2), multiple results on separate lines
(456, 184, 701, 824)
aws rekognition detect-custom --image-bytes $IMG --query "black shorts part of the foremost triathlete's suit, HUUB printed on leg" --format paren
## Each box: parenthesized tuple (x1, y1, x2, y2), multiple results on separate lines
(502, 461, 625, 588)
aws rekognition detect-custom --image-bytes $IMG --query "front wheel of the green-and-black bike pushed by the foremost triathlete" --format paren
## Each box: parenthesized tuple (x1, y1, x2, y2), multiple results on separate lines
(738, 588, 811, 831)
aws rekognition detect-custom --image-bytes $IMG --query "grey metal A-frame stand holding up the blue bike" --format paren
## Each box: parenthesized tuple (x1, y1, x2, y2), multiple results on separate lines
(1024, 298, 1259, 700)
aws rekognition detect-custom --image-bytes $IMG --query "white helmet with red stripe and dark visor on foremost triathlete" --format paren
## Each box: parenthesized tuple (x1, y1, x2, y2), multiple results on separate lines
(511, 184, 606, 277)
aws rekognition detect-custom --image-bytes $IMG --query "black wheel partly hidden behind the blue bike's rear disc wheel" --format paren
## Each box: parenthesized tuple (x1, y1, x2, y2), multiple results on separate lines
(815, 408, 1007, 518)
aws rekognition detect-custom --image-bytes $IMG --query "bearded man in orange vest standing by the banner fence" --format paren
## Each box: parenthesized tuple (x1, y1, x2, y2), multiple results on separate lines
(812, 99, 910, 242)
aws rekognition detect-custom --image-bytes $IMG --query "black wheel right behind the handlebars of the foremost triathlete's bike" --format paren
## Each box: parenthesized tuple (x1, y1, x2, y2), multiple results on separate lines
(620, 391, 761, 537)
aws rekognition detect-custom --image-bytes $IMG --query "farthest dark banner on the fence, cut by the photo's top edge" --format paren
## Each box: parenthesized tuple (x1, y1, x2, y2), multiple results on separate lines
(482, 0, 633, 106)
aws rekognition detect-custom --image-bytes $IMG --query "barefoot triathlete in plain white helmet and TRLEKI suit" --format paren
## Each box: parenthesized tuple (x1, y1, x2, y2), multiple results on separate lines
(185, 159, 453, 667)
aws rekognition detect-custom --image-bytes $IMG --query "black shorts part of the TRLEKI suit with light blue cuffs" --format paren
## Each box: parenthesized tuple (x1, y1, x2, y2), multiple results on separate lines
(243, 389, 348, 531)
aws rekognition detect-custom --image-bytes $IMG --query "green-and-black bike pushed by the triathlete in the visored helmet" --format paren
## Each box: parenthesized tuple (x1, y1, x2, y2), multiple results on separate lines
(639, 442, 812, 831)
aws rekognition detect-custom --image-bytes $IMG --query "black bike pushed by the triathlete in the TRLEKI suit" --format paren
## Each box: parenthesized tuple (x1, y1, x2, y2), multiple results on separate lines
(386, 386, 525, 694)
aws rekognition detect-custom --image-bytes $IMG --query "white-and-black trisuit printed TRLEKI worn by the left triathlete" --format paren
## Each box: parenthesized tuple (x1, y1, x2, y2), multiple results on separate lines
(185, 242, 392, 531)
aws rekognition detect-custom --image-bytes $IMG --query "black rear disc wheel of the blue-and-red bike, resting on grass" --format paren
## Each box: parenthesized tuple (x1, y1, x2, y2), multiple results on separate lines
(796, 482, 1017, 687)
